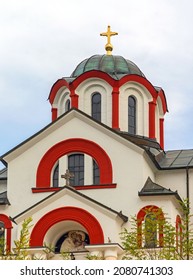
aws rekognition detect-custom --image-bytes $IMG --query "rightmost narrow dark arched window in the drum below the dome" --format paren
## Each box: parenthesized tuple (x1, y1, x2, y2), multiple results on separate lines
(128, 96, 136, 134)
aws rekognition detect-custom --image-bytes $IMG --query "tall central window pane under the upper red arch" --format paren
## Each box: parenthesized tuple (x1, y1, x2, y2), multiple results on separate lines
(68, 154, 84, 186)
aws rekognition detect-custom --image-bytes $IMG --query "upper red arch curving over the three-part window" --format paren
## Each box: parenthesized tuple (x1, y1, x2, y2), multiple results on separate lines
(36, 138, 112, 188)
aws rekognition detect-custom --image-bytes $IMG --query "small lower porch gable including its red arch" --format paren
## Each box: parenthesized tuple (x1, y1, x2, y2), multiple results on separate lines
(13, 187, 128, 246)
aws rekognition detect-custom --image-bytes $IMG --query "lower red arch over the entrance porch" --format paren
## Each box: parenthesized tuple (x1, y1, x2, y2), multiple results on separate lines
(30, 207, 104, 246)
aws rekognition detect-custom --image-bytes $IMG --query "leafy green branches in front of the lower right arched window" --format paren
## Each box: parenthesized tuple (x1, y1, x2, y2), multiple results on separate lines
(120, 202, 193, 260)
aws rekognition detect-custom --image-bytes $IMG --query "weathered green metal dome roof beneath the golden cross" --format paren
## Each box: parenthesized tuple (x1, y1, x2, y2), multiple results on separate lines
(71, 55, 145, 79)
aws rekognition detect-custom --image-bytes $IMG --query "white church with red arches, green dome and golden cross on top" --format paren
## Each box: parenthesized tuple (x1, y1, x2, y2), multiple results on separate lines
(0, 26, 193, 260)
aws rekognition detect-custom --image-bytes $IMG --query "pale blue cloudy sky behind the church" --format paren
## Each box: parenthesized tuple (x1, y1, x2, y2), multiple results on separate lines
(0, 0, 193, 168)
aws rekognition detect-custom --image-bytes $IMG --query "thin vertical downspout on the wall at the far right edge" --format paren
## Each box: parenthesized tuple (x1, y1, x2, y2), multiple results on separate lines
(185, 167, 190, 260)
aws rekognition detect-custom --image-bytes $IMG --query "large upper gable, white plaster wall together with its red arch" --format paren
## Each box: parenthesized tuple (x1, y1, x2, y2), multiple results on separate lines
(1, 110, 158, 218)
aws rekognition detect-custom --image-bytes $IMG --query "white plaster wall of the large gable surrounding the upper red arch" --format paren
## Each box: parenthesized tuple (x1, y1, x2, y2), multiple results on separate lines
(4, 112, 152, 218)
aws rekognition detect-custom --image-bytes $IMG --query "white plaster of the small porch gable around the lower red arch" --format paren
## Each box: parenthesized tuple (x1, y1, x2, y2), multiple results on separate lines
(14, 191, 123, 244)
